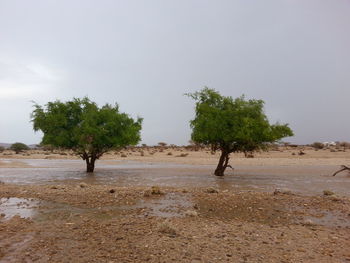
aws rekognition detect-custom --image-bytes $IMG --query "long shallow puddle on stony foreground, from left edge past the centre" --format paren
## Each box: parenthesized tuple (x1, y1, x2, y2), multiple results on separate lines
(0, 193, 192, 222)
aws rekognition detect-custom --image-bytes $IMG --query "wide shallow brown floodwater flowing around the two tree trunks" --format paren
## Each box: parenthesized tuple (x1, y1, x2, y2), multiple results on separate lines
(0, 159, 350, 195)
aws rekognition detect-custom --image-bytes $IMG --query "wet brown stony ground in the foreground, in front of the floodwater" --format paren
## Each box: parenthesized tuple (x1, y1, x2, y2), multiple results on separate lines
(0, 183, 350, 262)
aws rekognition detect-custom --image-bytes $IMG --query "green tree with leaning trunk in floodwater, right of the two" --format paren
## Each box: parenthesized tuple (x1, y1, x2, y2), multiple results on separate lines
(185, 88, 293, 176)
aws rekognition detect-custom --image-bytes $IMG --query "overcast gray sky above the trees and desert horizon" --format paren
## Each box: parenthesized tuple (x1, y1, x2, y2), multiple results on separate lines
(0, 0, 350, 144)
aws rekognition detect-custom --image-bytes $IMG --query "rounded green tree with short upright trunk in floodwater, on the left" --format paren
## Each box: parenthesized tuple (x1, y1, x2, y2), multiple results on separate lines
(31, 97, 142, 172)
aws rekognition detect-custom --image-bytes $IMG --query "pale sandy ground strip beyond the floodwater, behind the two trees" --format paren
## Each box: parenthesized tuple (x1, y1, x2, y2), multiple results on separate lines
(0, 147, 350, 167)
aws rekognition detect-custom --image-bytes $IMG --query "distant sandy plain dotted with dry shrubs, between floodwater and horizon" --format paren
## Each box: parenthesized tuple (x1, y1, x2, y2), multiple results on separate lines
(0, 143, 350, 166)
